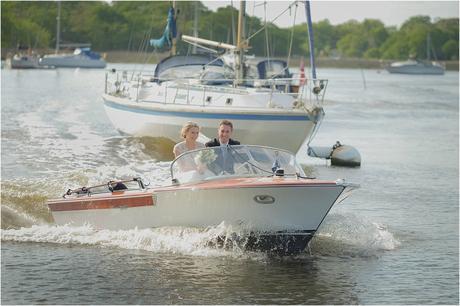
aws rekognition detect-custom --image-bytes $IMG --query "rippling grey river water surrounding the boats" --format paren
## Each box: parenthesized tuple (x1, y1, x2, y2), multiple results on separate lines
(1, 65, 459, 304)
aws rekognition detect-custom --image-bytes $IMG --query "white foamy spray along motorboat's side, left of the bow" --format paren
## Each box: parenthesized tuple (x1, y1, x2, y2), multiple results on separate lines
(2, 223, 255, 257)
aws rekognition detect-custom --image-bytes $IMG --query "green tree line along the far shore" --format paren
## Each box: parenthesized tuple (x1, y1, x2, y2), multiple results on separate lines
(1, 1, 459, 60)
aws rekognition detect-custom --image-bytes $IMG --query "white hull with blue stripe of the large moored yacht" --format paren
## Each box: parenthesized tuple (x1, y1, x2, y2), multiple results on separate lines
(104, 95, 324, 152)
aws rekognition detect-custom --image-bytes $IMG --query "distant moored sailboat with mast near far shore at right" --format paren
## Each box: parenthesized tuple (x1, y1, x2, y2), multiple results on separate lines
(386, 35, 445, 75)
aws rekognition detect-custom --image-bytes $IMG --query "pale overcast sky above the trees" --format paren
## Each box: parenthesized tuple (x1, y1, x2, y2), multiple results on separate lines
(203, 0, 459, 27)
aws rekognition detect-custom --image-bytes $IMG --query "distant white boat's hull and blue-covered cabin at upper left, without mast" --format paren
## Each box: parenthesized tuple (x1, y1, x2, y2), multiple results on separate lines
(40, 48, 107, 68)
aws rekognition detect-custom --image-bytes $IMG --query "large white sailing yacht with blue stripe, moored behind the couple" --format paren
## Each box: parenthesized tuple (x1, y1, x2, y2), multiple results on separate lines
(103, 1, 327, 152)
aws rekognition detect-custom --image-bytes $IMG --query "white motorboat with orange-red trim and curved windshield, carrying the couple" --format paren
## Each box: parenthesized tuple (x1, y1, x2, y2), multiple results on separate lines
(48, 145, 356, 254)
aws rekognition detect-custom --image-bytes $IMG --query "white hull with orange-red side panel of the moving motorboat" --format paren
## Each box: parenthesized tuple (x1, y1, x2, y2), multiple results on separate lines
(48, 178, 346, 254)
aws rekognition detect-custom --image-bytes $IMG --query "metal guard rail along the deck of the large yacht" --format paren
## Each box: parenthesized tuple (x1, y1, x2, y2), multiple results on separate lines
(105, 70, 328, 108)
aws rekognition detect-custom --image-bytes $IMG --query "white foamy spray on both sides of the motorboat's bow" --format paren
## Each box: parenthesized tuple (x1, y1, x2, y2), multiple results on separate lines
(1, 215, 399, 259)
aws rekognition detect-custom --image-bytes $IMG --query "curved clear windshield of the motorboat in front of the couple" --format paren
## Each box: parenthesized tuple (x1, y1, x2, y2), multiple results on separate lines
(171, 145, 304, 183)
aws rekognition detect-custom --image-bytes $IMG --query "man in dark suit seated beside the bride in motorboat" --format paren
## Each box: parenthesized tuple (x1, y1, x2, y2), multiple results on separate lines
(205, 120, 240, 174)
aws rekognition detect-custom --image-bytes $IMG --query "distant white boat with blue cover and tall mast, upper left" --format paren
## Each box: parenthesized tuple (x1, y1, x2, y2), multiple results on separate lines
(39, 1, 107, 68)
